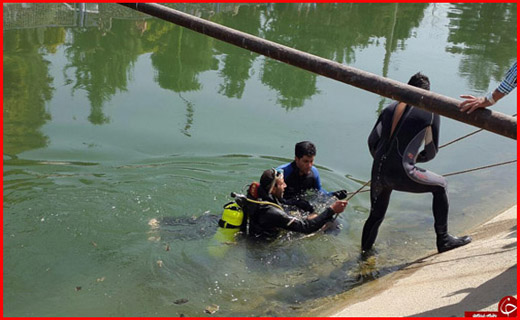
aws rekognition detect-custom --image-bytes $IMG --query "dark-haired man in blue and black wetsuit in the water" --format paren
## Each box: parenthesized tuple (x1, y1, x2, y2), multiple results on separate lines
(277, 141, 347, 212)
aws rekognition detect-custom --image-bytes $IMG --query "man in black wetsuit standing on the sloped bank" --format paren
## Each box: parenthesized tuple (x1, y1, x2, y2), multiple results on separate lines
(361, 73, 471, 252)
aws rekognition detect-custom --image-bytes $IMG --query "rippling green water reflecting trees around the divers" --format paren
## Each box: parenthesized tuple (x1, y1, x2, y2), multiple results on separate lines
(3, 3, 517, 317)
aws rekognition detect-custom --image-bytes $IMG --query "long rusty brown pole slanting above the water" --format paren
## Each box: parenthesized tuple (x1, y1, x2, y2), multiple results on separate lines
(121, 3, 517, 140)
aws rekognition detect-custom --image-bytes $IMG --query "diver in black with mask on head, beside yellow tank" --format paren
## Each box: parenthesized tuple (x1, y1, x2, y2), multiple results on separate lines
(244, 168, 347, 238)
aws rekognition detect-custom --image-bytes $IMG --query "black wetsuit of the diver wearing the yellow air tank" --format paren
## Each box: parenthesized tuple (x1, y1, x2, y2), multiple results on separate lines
(244, 192, 334, 239)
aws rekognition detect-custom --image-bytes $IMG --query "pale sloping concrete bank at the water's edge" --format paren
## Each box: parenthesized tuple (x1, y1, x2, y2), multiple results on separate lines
(323, 205, 517, 317)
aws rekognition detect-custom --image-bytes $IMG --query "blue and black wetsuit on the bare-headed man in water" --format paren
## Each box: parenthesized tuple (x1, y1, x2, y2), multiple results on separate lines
(277, 161, 329, 199)
